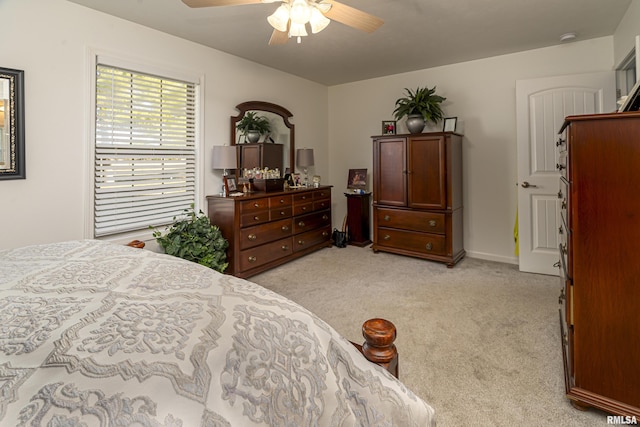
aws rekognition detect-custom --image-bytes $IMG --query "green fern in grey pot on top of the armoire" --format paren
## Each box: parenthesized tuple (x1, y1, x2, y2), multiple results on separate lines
(393, 86, 447, 133)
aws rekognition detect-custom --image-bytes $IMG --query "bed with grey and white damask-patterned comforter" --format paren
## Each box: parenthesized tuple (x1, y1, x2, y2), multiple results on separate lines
(0, 240, 435, 427)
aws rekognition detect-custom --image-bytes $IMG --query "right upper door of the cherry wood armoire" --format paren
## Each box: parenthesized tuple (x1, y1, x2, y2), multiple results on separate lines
(407, 135, 447, 209)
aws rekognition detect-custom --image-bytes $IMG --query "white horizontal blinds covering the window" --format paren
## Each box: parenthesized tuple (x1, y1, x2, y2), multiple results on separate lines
(94, 64, 196, 237)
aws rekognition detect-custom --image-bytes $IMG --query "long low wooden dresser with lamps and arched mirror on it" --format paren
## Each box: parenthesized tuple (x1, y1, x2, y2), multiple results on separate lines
(207, 186, 331, 278)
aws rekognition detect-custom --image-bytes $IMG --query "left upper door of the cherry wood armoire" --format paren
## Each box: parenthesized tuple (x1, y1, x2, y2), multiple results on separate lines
(373, 138, 407, 206)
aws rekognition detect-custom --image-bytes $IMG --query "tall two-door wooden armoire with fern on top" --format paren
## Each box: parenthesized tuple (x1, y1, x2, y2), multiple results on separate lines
(373, 132, 465, 267)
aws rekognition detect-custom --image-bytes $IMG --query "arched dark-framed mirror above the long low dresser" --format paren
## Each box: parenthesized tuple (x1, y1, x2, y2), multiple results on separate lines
(231, 101, 296, 172)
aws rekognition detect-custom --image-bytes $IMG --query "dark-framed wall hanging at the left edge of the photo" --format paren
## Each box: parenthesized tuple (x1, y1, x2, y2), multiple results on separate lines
(0, 68, 25, 179)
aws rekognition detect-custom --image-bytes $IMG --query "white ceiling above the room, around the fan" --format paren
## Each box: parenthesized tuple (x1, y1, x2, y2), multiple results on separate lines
(69, 0, 631, 86)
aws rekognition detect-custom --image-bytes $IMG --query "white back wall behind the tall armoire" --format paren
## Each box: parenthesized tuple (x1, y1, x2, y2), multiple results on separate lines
(329, 37, 613, 263)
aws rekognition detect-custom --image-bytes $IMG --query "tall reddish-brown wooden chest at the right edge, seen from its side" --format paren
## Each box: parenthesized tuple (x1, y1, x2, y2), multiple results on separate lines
(557, 113, 640, 418)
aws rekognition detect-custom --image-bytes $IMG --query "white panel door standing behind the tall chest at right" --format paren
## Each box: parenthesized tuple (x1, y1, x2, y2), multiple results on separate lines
(516, 71, 616, 275)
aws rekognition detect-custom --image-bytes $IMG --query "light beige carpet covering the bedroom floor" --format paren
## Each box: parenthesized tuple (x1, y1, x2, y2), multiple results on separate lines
(250, 246, 607, 427)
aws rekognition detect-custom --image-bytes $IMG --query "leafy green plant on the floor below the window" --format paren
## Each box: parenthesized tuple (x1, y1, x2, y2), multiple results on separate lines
(153, 207, 229, 273)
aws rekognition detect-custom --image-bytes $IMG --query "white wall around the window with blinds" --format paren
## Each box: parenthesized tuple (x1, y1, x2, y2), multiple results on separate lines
(0, 0, 329, 249)
